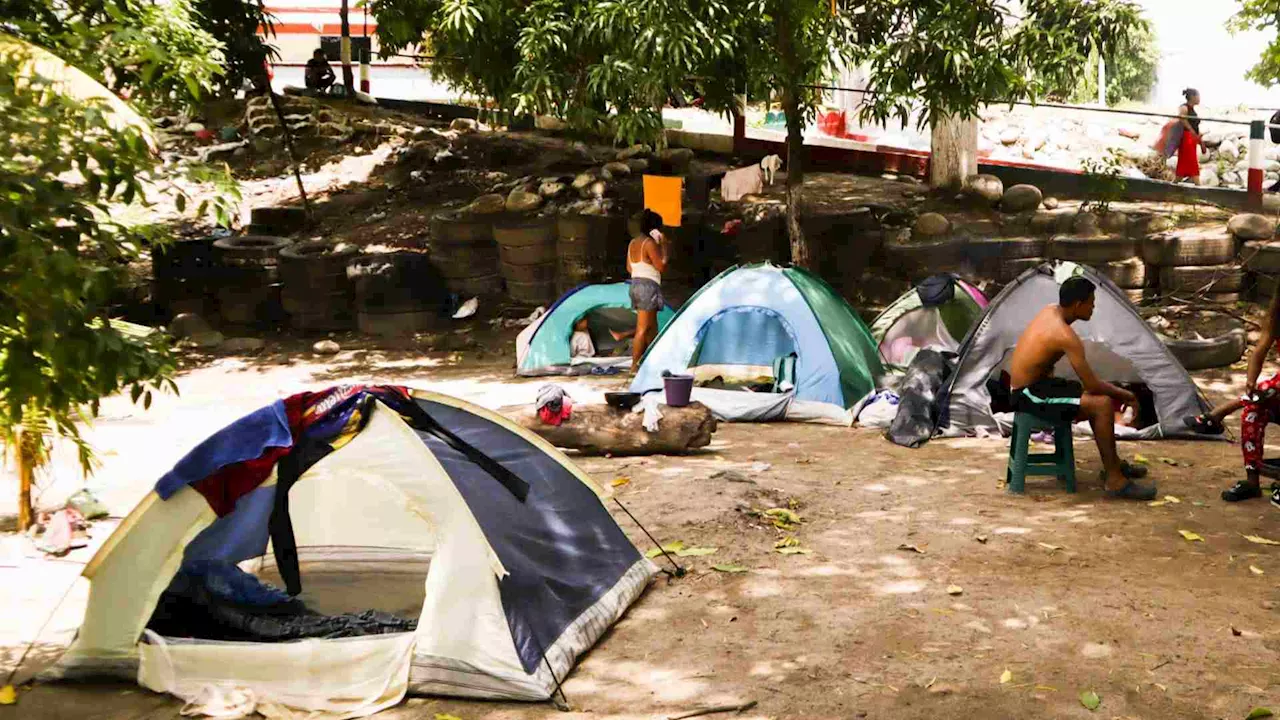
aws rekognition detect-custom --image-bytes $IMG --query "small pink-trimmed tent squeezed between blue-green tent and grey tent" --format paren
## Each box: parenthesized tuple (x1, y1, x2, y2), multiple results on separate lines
(872, 274, 987, 369)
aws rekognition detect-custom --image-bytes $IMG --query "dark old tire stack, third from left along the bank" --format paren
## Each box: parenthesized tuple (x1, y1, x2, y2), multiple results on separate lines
(279, 241, 356, 332)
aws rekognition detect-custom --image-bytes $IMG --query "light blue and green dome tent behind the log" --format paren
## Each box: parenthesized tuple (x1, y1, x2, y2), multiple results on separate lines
(631, 263, 882, 421)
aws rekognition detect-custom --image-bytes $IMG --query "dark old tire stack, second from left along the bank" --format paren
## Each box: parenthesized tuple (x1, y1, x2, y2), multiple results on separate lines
(214, 234, 291, 328)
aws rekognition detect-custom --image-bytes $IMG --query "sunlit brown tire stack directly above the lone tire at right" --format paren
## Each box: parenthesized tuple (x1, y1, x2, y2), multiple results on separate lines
(1142, 220, 1244, 304)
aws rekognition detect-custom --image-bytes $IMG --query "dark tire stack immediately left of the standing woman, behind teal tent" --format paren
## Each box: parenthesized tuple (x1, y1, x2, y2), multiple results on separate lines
(556, 209, 628, 295)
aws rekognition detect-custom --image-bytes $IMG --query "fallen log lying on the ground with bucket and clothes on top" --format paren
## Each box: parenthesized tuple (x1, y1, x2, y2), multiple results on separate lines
(502, 402, 716, 455)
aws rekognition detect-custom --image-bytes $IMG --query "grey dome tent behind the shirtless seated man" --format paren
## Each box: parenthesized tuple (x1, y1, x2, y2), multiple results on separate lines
(938, 261, 1210, 439)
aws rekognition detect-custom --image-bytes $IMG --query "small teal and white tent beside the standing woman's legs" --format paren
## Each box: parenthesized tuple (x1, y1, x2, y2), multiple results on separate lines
(516, 281, 676, 377)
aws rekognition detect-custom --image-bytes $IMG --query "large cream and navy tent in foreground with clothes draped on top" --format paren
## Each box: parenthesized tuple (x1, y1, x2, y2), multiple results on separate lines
(46, 386, 657, 717)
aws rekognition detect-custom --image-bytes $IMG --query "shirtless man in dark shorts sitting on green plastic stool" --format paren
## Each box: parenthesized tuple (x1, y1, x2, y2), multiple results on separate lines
(1009, 277, 1156, 500)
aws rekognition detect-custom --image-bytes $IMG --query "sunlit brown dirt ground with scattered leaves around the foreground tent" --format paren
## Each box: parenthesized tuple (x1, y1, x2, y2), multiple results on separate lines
(0, 340, 1280, 720)
